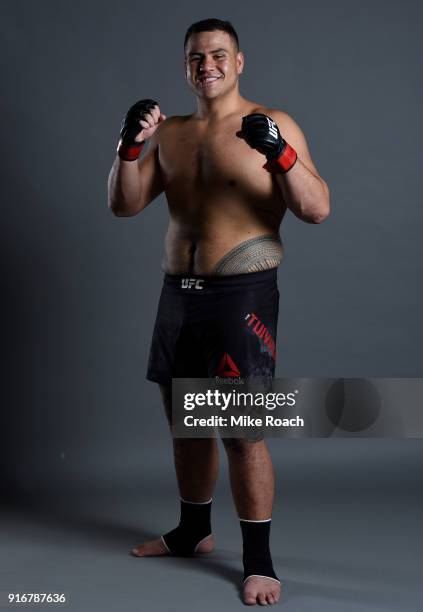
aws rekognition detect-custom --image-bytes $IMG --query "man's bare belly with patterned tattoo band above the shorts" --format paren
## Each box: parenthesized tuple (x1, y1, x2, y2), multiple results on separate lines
(162, 224, 283, 275)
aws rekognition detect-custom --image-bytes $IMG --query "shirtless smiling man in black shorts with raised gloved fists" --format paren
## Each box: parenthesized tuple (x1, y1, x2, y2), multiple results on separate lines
(109, 19, 329, 605)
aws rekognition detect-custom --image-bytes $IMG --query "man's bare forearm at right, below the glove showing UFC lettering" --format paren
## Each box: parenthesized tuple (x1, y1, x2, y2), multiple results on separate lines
(275, 159, 329, 223)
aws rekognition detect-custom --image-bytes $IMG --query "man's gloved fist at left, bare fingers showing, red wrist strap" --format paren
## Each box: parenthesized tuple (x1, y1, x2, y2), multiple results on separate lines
(117, 99, 166, 161)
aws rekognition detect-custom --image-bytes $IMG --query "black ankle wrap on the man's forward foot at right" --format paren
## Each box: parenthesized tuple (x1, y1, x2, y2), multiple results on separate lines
(239, 519, 279, 582)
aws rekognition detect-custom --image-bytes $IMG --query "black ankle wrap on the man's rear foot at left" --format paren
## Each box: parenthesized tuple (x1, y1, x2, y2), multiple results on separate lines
(162, 499, 212, 557)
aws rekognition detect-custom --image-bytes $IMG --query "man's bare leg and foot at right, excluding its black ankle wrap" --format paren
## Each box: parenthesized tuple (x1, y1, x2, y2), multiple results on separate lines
(222, 438, 281, 605)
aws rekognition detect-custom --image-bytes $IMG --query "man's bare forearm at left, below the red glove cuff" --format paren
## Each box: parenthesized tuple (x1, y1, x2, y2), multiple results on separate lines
(108, 156, 141, 217)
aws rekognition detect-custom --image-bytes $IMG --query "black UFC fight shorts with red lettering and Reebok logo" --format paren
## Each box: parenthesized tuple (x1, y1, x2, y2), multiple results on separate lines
(147, 268, 279, 385)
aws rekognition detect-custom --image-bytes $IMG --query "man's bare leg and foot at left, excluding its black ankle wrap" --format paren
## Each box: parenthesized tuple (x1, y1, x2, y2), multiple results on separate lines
(131, 385, 219, 557)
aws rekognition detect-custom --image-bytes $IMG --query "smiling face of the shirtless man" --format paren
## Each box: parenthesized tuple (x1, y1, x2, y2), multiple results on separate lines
(185, 30, 244, 99)
